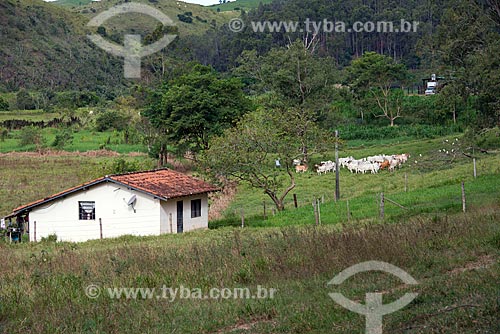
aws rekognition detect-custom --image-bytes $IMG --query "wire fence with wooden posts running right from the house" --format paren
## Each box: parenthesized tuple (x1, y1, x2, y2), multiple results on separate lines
(210, 175, 500, 228)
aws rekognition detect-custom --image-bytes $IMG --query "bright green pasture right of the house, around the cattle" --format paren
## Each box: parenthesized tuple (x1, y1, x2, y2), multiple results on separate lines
(211, 137, 500, 227)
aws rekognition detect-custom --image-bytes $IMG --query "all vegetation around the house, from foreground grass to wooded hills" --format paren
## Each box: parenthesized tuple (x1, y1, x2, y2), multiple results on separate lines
(0, 0, 500, 333)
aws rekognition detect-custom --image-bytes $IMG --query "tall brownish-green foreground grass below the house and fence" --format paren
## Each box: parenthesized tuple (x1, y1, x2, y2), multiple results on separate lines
(0, 206, 500, 333)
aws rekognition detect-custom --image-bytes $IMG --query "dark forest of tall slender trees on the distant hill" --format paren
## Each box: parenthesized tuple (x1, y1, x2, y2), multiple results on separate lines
(190, 0, 457, 70)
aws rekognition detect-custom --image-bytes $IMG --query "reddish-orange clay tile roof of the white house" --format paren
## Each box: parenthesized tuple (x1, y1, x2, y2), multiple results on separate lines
(6, 169, 219, 218)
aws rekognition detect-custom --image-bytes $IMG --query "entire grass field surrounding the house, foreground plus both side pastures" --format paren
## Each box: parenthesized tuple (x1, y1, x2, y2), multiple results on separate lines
(0, 133, 500, 334)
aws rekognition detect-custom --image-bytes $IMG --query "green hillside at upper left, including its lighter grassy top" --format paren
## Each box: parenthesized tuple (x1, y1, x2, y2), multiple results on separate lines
(0, 0, 234, 92)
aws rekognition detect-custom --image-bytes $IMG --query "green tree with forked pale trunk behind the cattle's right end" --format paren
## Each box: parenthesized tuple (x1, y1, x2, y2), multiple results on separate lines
(348, 52, 408, 126)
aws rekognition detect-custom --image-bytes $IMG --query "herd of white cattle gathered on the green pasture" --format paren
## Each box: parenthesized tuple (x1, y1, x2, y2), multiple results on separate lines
(293, 153, 410, 175)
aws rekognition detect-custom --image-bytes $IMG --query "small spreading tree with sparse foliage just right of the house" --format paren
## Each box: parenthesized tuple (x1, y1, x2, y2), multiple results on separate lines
(201, 109, 332, 211)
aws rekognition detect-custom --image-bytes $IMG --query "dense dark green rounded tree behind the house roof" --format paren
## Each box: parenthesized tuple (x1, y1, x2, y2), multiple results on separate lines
(145, 65, 251, 156)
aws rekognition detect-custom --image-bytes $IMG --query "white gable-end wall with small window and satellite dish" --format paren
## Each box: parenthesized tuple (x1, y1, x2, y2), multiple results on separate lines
(29, 183, 160, 241)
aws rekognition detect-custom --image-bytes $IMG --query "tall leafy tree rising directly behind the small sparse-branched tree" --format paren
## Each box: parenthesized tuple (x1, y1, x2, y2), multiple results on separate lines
(235, 40, 334, 162)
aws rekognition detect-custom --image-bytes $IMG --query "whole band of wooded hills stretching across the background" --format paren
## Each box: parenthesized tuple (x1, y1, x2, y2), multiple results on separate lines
(0, 0, 500, 92)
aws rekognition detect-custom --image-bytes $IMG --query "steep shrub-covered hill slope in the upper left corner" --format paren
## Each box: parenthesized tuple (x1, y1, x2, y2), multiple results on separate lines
(0, 0, 127, 90)
